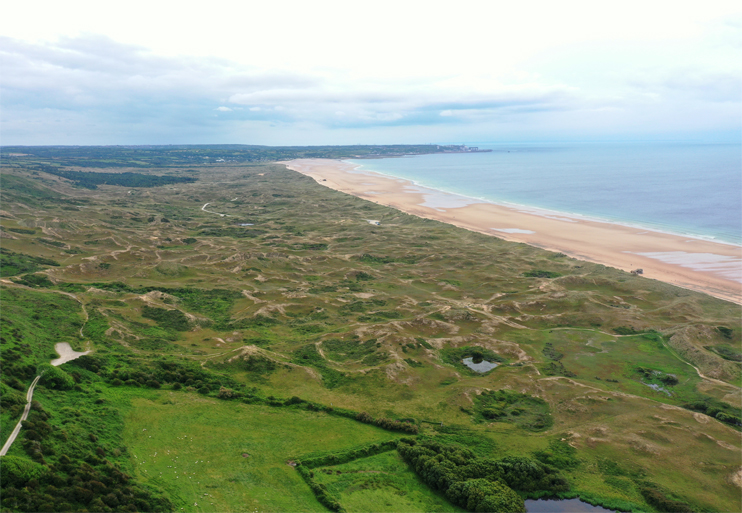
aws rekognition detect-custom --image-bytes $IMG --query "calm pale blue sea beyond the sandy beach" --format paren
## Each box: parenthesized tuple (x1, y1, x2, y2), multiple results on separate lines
(350, 143, 742, 245)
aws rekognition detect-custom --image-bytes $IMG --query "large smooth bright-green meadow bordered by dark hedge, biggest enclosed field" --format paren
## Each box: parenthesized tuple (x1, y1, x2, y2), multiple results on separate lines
(122, 391, 402, 511)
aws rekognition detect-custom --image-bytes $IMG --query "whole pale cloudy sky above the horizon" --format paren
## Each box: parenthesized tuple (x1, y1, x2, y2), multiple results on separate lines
(0, 0, 742, 145)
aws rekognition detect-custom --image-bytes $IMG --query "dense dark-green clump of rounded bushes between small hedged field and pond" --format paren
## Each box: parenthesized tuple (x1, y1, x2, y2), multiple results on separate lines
(397, 439, 569, 512)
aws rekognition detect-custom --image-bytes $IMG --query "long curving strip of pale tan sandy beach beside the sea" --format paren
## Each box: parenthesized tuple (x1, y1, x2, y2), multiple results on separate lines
(284, 159, 742, 304)
